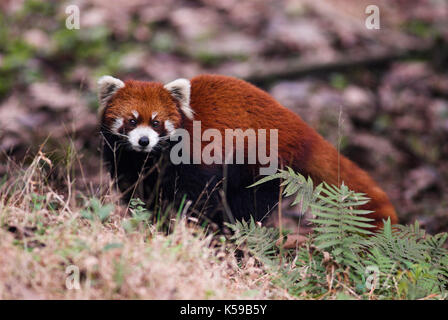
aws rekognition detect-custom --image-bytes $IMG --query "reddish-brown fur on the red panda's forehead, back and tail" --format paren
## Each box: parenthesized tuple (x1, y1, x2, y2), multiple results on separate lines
(105, 75, 398, 227)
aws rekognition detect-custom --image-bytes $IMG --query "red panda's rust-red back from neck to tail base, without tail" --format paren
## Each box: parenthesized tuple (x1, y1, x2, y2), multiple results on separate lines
(190, 75, 320, 167)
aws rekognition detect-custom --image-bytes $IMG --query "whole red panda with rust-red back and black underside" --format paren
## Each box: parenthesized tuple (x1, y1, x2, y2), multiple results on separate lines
(98, 75, 398, 228)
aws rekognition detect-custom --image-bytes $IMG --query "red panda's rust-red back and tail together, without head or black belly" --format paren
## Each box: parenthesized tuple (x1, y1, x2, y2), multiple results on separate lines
(186, 75, 398, 226)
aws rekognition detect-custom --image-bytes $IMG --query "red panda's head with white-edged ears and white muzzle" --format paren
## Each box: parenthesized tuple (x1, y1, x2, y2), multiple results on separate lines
(98, 76, 193, 152)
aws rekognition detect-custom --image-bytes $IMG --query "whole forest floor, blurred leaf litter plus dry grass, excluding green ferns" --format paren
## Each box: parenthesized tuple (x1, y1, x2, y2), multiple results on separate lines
(0, 0, 448, 299)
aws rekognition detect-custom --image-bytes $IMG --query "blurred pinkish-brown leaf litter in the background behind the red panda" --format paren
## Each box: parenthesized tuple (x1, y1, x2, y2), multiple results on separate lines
(0, 0, 448, 232)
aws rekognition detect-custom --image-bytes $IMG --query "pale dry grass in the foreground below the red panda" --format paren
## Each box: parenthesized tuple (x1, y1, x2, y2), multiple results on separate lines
(0, 152, 290, 299)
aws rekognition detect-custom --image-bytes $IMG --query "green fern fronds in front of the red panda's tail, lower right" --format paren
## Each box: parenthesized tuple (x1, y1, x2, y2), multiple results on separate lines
(230, 168, 448, 299)
